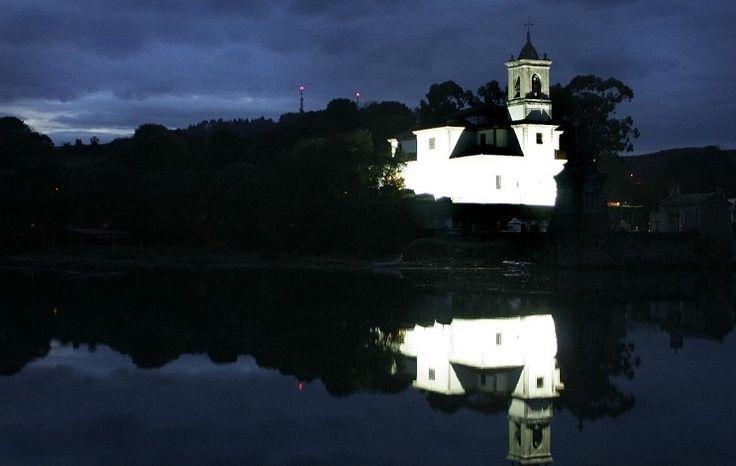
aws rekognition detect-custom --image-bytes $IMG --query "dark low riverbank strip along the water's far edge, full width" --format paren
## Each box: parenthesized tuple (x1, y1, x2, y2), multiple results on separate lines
(0, 232, 734, 273)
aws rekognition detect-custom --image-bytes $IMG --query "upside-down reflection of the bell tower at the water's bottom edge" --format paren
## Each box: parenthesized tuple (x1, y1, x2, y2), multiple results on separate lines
(506, 398, 552, 464)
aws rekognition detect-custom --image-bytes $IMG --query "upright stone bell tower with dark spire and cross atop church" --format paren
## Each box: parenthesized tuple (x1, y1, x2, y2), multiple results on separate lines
(506, 23, 552, 122)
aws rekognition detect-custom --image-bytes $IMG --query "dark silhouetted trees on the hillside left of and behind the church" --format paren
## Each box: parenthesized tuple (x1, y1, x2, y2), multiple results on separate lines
(0, 76, 637, 253)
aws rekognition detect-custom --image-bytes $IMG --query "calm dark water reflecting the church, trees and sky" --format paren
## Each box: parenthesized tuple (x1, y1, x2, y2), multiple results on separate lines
(0, 270, 736, 465)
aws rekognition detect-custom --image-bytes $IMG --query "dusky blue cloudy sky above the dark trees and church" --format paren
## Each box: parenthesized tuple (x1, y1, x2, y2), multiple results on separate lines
(0, 0, 736, 153)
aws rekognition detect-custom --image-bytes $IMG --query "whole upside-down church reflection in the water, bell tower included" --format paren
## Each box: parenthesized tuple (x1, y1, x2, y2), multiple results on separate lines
(399, 315, 563, 464)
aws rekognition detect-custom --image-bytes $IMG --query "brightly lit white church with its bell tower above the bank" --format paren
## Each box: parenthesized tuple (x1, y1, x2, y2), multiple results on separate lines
(389, 33, 565, 206)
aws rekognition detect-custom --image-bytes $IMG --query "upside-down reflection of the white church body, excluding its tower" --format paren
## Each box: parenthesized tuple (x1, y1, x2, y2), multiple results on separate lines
(399, 314, 563, 399)
